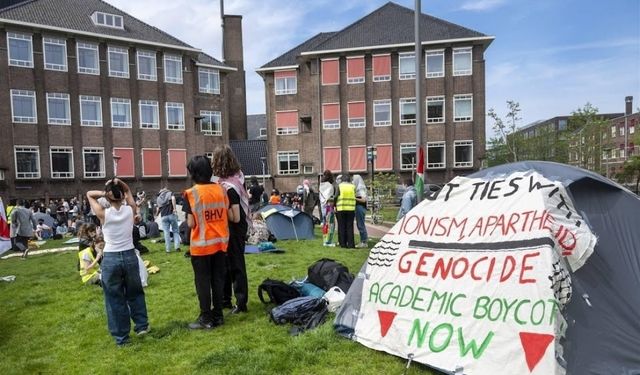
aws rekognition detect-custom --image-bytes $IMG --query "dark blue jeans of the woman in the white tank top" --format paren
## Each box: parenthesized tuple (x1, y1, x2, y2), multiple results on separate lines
(100, 249, 149, 345)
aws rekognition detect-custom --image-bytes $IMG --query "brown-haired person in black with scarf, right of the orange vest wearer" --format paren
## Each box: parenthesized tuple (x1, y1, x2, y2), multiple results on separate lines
(211, 145, 251, 314)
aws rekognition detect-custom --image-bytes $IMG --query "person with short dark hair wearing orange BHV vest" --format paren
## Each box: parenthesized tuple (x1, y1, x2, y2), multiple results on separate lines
(182, 155, 235, 329)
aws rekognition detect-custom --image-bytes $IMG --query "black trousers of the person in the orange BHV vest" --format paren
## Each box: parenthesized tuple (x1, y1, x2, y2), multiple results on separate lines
(191, 251, 227, 323)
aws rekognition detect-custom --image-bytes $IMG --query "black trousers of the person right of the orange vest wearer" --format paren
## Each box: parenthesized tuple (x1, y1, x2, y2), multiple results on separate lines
(224, 234, 249, 309)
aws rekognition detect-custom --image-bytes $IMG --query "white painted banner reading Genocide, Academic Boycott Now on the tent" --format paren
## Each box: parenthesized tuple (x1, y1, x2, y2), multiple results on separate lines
(355, 172, 596, 375)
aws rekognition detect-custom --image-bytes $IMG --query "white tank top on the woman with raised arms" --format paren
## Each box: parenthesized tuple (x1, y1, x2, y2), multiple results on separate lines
(102, 204, 133, 253)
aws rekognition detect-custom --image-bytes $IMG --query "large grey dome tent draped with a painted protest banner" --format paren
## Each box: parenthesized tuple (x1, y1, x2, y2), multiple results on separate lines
(335, 162, 640, 374)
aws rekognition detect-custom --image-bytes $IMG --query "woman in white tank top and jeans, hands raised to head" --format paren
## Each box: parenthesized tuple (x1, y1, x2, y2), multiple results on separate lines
(87, 178, 149, 346)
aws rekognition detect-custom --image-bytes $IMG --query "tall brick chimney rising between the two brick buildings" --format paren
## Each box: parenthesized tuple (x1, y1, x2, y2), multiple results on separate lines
(221, 14, 247, 140)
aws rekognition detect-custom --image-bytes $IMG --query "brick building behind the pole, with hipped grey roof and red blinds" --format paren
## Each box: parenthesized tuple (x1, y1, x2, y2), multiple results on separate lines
(257, 2, 494, 191)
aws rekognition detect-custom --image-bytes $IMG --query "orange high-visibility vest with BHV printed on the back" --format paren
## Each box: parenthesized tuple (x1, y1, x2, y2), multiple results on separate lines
(185, 183, 229, 256)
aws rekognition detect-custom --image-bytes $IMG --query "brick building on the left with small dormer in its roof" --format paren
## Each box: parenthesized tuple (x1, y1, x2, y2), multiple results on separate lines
(0, 0, 246, 204)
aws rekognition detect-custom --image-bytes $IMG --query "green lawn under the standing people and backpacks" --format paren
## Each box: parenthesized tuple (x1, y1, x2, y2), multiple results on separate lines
(0, 234, 432, 375)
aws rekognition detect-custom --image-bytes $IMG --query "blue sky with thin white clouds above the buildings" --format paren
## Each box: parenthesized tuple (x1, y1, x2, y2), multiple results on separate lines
(106, 0, 640, 137)
